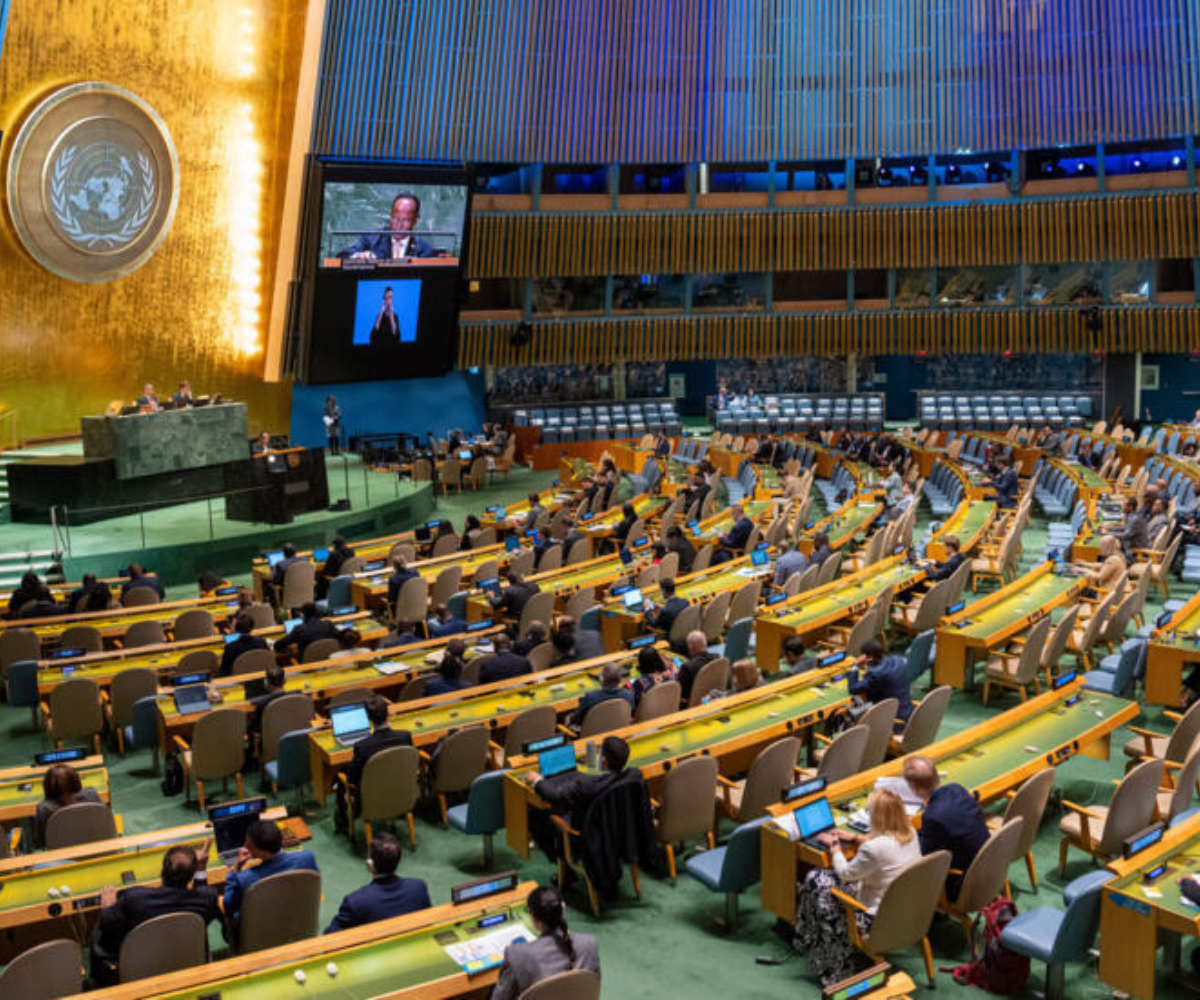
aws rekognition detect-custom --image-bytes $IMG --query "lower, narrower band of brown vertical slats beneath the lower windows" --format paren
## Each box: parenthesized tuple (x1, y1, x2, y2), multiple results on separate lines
(458, 306, 1200, 367)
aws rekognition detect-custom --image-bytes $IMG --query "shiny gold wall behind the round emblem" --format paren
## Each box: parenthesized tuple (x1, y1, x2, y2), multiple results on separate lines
(0, 0, 305, 437)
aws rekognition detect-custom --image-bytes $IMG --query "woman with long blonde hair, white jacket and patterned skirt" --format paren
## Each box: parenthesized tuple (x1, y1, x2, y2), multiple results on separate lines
(793, 789, 920, 986)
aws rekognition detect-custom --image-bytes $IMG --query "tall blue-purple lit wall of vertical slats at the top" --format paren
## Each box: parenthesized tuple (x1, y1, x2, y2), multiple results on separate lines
(314, 0, 1200, 163)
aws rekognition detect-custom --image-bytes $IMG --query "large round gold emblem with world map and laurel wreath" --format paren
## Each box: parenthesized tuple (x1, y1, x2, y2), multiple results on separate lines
(8, 83, 179, 282)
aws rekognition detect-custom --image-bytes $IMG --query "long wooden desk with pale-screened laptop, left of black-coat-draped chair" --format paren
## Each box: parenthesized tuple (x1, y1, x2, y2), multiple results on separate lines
(308, 642, 679, 796)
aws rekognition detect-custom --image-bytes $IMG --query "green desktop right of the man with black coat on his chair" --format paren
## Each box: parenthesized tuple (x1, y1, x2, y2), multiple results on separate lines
(604, 681, 850, 767)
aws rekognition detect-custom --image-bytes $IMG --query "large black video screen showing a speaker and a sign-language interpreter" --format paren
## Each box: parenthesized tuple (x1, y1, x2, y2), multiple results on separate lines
(302, 163, 470, 383)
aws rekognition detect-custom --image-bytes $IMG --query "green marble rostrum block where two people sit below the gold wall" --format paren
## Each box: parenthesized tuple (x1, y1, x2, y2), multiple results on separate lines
(80, 403, 250, 479)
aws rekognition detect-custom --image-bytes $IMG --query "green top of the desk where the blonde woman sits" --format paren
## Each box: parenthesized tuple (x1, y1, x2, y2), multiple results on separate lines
(836, 690, 1129, 825)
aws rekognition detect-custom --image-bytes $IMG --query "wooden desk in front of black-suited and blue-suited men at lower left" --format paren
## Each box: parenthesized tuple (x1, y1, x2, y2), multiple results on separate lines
(0, 807, 304, 962)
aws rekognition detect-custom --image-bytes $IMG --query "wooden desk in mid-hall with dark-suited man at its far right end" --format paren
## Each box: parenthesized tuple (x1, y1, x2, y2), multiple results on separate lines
(755, 555, 925, 673)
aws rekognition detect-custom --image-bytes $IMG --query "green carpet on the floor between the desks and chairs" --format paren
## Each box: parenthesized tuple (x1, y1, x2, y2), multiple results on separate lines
(0, 471, 1183, 1000)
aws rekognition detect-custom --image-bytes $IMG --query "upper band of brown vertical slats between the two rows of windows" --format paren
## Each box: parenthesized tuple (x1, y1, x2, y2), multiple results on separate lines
(467, 191, 1200, 277)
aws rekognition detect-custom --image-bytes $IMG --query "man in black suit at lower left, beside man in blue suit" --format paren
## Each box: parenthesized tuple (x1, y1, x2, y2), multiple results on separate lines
(91, 840, 221, 986)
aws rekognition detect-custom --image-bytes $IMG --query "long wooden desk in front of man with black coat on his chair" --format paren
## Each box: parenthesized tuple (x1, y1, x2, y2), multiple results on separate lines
(504, 669, 850, 854)
